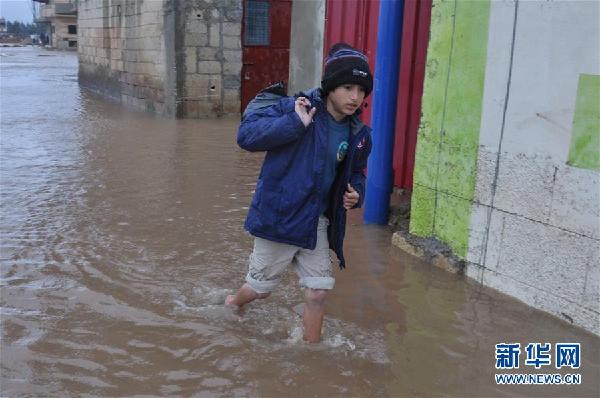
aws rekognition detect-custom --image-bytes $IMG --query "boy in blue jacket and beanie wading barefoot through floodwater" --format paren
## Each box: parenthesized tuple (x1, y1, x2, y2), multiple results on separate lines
(225, 43, 373, 342)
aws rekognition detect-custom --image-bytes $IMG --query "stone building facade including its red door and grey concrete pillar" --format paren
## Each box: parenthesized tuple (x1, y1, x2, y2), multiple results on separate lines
(78, 0, 326, 118)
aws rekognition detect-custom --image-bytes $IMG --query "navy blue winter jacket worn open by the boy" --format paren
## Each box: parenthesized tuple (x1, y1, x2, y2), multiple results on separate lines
(237, 89, 371, 268)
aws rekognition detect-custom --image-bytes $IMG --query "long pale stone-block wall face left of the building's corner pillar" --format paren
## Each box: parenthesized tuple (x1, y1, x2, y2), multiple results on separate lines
(78, 0, 168, 114)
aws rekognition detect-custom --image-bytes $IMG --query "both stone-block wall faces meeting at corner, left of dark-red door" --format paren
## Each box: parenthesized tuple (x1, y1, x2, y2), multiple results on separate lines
(78, 0, 242, 118)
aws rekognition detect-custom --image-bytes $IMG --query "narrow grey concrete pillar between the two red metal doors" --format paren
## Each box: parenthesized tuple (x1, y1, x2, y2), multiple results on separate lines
(288, 0, 326, 95)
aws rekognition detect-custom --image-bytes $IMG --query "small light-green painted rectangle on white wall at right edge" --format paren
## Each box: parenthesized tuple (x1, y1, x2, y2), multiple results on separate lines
(567, 74, 600, 171)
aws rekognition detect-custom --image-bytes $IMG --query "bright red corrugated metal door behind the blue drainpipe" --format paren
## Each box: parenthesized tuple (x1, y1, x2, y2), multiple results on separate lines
(324, 0, 432, 190)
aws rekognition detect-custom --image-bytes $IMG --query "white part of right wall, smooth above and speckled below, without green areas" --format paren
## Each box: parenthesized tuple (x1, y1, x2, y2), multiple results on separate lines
(467, 0, 600, 334)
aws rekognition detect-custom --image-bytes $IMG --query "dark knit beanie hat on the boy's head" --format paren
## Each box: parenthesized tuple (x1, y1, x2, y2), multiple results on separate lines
(321, 43, 373, 97)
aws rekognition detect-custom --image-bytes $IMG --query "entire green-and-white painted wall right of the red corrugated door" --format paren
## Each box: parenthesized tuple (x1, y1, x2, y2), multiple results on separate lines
(411, 0, 600, 334)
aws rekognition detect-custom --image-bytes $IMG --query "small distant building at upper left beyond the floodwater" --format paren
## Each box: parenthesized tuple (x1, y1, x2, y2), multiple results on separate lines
(33, 0, 77, 50)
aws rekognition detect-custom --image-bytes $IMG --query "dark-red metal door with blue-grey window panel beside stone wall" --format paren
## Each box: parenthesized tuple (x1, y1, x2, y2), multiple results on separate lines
(241, 0, 292, 112)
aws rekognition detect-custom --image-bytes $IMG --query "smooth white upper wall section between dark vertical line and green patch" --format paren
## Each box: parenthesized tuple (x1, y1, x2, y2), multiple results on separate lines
(502, 1, 600, 163)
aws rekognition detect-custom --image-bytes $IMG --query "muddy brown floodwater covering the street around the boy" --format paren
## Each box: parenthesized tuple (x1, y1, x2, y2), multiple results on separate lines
(0, 48, 600, 397)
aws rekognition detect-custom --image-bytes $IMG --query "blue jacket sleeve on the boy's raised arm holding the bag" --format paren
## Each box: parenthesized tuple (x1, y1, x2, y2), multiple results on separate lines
(237, 98, 306, 152)
